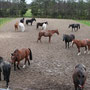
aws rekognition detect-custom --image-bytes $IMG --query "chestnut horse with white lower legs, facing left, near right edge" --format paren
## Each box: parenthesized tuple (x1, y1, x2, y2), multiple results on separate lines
(72, 39, 88, 55)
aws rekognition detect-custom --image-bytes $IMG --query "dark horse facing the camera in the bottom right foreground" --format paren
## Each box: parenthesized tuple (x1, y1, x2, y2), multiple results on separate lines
(72, 64, 86, 90)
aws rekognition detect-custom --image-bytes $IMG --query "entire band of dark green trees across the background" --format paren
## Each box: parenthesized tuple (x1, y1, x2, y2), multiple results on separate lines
(0, 0, 90, 19)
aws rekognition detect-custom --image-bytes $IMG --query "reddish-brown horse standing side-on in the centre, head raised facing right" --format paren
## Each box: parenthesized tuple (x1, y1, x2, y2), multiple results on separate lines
(37, 30, 59, 43)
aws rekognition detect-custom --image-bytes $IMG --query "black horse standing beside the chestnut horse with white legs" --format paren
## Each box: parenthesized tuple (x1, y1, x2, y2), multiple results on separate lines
(63, 34, 75, 48)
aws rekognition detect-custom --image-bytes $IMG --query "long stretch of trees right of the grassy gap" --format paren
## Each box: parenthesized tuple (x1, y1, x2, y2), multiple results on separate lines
(30, 0, 90, 19)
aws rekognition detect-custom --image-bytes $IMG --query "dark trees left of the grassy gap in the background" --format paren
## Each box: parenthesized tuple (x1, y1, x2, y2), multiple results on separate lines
(0, 0, 27, 17)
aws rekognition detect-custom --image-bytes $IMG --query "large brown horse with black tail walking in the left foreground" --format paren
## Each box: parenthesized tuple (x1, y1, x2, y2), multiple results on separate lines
(11, 48, 32, 70)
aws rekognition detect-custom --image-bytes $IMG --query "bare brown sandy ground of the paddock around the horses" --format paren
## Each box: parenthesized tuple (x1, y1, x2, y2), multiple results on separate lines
(0, 18, 90, 90)
